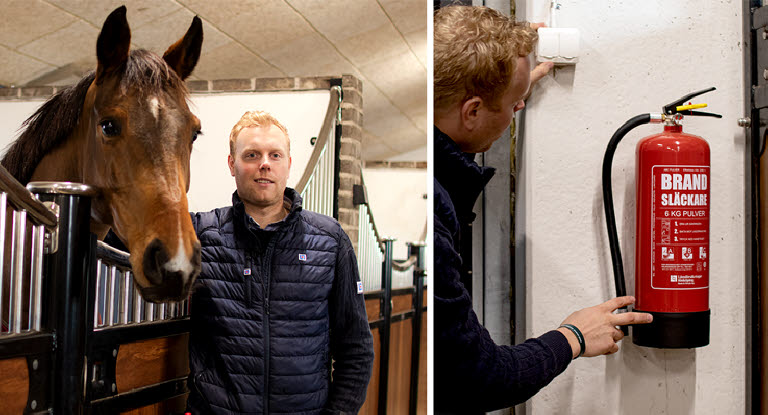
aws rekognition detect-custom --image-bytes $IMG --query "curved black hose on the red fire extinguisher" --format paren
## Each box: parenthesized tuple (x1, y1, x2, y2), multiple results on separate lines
(603, 114, 651, 309)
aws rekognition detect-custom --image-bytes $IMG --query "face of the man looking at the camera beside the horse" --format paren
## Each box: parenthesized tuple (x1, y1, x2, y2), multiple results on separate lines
(229, 125, 291, 208)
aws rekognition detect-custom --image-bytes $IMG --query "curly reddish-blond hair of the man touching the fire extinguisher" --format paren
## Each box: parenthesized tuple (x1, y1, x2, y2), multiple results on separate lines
(434, 6, 538, 109)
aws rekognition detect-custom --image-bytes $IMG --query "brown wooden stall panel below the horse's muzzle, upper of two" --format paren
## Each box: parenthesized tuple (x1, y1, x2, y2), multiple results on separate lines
(115, 333, 189, 393)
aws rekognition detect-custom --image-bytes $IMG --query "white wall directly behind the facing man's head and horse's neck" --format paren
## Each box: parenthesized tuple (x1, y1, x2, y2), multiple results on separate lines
(0, 90, 330, 211)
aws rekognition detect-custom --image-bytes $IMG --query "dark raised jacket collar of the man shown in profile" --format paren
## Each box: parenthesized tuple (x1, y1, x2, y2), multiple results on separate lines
(434, 127, 496, 222)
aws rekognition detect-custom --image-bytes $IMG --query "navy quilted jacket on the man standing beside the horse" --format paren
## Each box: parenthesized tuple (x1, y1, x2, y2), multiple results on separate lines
(187, 188, 373, 414)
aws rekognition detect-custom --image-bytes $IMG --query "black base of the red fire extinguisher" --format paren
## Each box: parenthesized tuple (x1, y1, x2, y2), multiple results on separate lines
(632, 310, 710, 349)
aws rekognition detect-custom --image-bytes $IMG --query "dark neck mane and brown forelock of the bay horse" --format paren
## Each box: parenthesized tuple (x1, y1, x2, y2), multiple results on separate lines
(0, 49, 189, 185)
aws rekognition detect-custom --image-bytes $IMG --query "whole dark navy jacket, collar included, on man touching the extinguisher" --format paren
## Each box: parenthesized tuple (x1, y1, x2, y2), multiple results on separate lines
(434, 127, 572, 414)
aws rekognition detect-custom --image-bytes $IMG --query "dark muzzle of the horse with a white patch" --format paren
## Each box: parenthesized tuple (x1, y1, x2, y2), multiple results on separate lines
(141, 238, 201, 303)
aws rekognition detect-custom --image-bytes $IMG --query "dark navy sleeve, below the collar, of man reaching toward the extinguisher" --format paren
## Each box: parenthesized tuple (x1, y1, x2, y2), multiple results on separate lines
(434, 216, 572, 413)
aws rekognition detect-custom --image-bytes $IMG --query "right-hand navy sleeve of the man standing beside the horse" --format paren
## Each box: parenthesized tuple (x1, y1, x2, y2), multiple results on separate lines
(323, 230, 373, 414)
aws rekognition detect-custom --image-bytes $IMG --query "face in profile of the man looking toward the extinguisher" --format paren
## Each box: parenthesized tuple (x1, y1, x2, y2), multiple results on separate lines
(460, 57, 531, 153)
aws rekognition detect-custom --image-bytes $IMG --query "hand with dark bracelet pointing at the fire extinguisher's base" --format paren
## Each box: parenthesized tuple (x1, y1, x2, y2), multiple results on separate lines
(558, 296, 653, 358)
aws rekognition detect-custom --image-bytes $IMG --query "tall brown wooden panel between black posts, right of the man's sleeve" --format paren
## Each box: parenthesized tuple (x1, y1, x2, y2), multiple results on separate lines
(387, 319, 413, 414)
